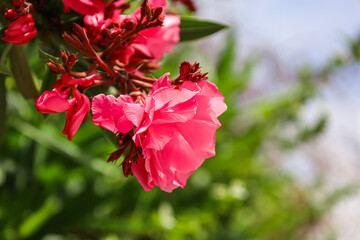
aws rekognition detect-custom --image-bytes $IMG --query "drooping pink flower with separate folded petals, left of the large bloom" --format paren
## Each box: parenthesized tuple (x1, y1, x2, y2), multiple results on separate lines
(35, 73, 97, 140)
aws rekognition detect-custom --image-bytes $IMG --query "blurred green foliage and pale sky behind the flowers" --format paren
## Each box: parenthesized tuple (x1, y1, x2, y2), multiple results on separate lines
(0, 0, 360, 240)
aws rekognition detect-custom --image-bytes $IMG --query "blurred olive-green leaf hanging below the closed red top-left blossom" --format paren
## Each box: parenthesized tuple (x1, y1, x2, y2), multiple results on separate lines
(9, 45, 39, 99)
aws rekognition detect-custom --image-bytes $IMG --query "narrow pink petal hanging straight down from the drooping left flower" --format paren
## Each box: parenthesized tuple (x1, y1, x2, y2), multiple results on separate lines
(63, 90, 90, 140)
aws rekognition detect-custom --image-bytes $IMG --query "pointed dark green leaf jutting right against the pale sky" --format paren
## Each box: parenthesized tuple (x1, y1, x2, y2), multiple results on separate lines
(180, 16, 228, 41)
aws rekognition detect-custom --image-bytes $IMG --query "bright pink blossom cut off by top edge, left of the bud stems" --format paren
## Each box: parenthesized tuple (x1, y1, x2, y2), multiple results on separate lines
(64, 0, 105, 15)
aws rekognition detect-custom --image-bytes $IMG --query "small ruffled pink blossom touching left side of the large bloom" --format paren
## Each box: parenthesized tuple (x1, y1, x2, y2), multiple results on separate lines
(91, 94, 144, 133)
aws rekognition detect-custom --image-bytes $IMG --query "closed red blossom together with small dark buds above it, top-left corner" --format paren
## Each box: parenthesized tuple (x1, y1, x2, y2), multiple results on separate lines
(1, 0, 37, 44)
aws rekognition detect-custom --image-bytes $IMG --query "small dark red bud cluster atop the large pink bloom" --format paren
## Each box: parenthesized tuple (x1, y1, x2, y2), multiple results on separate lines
(175, 61, 208, 83)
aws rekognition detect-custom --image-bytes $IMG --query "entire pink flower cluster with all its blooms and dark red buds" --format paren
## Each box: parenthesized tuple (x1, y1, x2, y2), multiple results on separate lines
(3, 0, 227, 192)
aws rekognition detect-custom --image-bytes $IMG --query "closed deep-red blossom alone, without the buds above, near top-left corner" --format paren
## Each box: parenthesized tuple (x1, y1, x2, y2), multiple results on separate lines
(1, 13, 37, 44)
